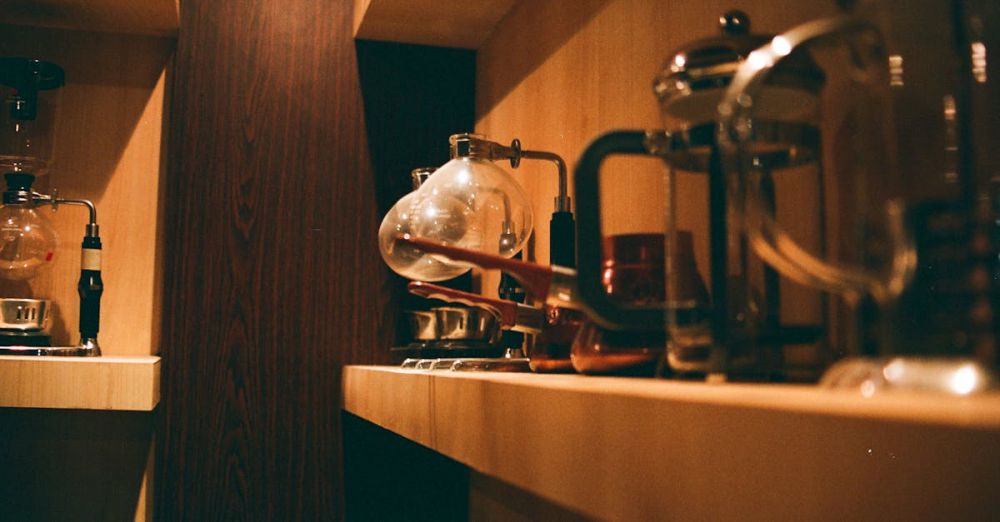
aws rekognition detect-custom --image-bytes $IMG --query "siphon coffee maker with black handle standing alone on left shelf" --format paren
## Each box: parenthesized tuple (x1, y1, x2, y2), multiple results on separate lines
(0, 57, 104, 356)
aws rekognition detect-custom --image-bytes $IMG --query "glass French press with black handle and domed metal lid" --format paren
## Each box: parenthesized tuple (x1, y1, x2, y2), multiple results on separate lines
(575, 11, 825, 380)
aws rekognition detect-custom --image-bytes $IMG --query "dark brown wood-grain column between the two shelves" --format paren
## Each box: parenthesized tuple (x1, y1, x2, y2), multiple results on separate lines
(155, 0, 472, 520)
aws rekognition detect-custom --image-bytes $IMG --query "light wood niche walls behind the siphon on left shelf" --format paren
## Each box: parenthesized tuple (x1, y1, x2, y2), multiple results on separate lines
(0, 26, 175, 355)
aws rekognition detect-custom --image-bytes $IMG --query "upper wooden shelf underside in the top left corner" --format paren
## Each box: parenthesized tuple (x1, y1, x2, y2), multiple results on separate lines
(0, 0, 180, 36)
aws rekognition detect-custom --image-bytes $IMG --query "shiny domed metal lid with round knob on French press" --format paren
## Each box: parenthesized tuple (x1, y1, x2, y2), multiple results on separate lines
(653, 11, 826, 125)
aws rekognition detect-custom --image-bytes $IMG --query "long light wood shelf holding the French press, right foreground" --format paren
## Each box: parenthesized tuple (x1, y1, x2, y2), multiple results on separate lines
(344, 366, 1000, 520)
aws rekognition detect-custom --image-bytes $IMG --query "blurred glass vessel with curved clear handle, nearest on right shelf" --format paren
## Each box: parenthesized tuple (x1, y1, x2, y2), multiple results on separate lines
(719, 0, 1000, 395)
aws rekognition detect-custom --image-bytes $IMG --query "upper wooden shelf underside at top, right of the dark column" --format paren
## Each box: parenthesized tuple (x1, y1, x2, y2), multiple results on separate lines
(354, 0, 518, 49)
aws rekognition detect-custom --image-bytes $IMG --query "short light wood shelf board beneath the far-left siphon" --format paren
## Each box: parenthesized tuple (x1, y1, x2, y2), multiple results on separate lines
(0, 355, 160, 411)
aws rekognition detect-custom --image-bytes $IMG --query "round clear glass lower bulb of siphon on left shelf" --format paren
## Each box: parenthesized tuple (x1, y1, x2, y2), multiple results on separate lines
(0, 205, 57, 280)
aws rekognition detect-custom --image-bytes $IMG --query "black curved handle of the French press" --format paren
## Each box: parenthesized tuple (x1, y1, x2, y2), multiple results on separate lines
(574, 130, 666, 331)
